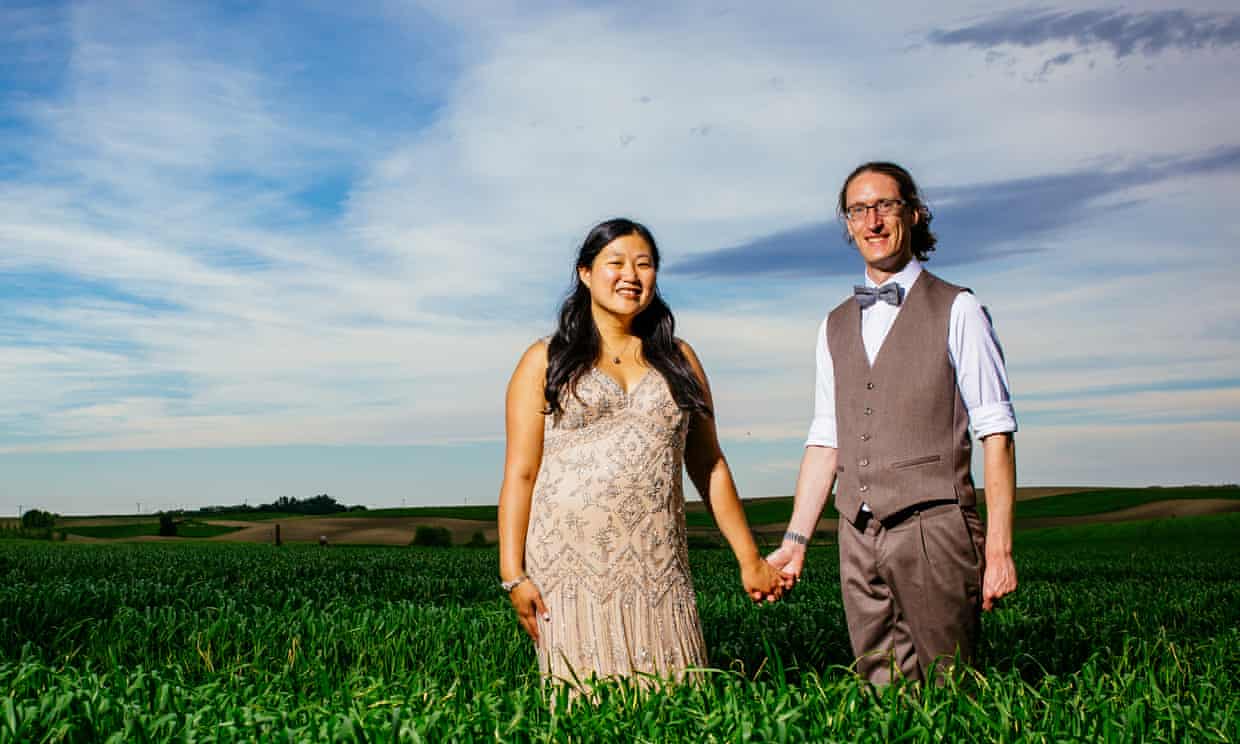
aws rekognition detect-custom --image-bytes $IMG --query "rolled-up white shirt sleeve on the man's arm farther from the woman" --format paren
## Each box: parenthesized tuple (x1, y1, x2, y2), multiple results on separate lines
(947, 291, 1017, 438)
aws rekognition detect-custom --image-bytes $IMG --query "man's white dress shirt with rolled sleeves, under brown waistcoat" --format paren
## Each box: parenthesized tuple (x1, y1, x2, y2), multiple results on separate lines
(805, 258, 1016, 448)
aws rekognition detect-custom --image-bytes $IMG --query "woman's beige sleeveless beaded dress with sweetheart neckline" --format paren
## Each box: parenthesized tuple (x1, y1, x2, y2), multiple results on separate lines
(526, 368, 706, 683)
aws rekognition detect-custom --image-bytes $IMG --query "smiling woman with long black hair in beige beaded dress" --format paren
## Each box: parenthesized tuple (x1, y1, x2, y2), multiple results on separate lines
(500, 219, 781, 681)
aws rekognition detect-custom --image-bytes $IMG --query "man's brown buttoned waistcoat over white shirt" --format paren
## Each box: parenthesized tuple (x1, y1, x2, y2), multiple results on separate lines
(827, 272, 977, 521)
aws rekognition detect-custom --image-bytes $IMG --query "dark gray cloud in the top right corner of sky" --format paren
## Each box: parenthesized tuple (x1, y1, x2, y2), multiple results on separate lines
(926, 9, 1240, 63)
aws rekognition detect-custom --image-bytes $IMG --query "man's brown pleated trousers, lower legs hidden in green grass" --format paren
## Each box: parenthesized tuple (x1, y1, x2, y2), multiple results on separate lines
(839, 502, 986, 684)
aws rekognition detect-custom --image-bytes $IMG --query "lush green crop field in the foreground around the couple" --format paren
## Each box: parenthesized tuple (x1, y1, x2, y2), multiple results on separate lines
(0, 515, 1240, 743)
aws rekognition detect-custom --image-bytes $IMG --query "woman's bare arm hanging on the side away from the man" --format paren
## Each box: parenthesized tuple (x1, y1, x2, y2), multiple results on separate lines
(498, 341, 547, 641)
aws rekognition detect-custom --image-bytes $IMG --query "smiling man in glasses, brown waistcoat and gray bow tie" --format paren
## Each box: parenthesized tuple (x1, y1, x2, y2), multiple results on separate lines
(768, 162, 1017, 684)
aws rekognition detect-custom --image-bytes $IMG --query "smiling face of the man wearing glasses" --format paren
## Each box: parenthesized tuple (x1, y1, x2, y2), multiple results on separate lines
(844, 171, 920, 274)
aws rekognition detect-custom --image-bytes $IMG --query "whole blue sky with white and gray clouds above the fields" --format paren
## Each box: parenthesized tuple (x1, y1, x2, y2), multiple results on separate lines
(0, 0, 1240, 513)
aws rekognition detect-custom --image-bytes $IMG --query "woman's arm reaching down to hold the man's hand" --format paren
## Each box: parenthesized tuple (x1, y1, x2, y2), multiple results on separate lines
(680, 341, 782, 601)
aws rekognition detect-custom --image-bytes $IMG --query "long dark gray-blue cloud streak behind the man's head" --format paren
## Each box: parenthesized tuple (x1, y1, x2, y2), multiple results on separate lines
(668, 145, 1240, 277)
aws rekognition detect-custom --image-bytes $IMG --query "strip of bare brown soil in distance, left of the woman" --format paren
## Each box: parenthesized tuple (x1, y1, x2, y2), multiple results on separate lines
(206, 517, 498, 546)
